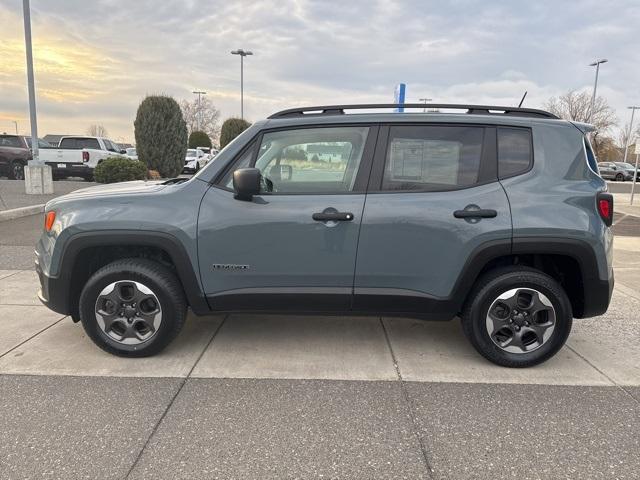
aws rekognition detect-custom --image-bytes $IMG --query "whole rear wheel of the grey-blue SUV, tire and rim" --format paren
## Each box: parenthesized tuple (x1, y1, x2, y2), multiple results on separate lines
(462, 267, 573, 367)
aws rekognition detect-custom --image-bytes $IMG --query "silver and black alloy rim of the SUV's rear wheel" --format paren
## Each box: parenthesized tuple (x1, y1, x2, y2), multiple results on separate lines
(486, 288, 556, 353)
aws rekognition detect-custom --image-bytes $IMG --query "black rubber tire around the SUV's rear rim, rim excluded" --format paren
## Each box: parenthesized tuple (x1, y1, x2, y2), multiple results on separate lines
(461, 266, 573, 367)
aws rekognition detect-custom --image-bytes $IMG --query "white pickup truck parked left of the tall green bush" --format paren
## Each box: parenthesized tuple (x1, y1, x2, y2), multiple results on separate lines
(40, 136, 125, 180)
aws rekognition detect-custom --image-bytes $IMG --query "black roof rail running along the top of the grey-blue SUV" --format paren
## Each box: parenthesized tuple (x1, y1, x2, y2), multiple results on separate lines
(268, 103, 558, 119)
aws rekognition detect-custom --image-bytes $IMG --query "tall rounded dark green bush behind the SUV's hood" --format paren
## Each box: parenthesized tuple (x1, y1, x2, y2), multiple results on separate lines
(133, 95, 187, 178)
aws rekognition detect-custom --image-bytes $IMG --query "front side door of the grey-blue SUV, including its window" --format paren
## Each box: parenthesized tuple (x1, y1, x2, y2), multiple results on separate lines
(198, 125, 377, 312)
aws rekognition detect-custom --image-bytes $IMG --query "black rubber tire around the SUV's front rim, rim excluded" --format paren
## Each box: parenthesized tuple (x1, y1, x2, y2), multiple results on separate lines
(79, 258, 187, 357)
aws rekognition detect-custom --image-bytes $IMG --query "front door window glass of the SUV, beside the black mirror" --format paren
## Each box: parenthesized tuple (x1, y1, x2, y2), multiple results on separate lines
(255, 127, 369, 194)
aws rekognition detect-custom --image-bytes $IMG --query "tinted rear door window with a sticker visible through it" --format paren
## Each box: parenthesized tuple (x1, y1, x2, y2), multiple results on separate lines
(382, 125, 484, 191)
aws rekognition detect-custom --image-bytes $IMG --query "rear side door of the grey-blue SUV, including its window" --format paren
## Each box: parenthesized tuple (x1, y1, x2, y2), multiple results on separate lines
(354, 124, 511, 318)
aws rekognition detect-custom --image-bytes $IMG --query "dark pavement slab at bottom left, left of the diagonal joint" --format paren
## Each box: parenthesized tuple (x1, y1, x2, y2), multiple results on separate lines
(0, 375, 180, 479)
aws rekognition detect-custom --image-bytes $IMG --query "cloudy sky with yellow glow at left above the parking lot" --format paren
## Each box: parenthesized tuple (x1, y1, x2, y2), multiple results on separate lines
(0, 0, 640, 141)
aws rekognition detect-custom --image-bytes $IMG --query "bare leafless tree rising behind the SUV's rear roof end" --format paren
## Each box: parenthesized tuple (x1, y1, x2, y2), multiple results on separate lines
(545, 90, 618, 156)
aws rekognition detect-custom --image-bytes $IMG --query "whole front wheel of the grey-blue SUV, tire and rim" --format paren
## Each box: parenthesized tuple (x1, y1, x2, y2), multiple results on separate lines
(79, 258, 187, 357)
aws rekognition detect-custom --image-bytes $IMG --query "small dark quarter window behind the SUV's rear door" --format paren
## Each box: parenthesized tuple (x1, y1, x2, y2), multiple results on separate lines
(498, 127, 533, 178)
